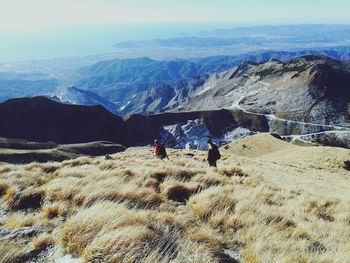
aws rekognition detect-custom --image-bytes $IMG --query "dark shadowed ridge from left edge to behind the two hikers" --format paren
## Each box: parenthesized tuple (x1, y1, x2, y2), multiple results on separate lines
(0, 97, 268, 147)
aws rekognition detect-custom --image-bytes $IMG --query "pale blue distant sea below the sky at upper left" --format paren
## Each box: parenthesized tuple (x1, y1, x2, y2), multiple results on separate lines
(0, 23, 227, 63)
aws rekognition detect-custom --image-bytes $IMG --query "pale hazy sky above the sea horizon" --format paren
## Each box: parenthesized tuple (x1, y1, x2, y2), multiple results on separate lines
(0, 0, 350, 31)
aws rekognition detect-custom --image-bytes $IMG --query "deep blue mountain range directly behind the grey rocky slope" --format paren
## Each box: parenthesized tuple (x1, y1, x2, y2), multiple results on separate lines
(74, 47, 350, 109)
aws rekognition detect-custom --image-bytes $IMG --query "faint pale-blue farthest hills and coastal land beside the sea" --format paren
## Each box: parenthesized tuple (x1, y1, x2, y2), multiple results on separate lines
(115, 25, 350, 60)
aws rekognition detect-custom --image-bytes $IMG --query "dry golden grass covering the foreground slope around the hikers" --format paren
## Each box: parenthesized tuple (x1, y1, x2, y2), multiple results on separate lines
(0, 135, 350, 262)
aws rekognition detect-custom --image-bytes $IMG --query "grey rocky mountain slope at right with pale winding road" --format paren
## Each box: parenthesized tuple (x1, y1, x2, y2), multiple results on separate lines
(177, 56, 350, 126)
